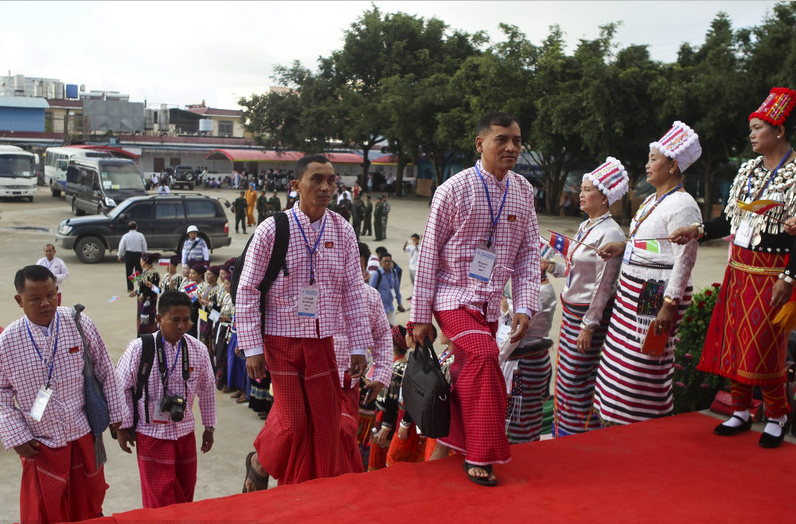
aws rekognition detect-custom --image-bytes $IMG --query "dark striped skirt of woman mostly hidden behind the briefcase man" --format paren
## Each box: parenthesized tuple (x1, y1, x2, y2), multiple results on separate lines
(502, 348, 552, 444)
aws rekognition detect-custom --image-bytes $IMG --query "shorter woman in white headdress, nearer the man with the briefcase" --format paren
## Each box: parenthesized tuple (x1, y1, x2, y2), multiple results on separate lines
(542, 157, 628, 437)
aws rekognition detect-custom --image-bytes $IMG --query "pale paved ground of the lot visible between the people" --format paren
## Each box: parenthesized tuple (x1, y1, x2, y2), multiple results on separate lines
(0, 184, 776, 523)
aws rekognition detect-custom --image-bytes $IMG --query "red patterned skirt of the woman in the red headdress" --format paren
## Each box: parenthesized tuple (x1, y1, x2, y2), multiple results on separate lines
(697, 245, 788, 386)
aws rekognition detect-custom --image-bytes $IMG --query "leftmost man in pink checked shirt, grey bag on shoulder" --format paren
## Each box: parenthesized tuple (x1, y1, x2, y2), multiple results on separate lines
(0, 265, 125, 524)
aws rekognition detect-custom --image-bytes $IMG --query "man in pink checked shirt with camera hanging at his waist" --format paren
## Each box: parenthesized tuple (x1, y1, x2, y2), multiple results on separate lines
(116, 291, 216, 508)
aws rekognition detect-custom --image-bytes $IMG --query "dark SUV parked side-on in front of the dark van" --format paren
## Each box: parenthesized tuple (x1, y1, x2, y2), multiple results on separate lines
(55, 195, 232, 264)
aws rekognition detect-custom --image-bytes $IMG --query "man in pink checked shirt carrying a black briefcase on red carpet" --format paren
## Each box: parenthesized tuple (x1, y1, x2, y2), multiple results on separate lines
(410, 112, 539, 486)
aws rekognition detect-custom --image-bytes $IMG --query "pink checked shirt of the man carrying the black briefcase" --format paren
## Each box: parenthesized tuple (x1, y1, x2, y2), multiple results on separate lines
(410, 161, 539, 323)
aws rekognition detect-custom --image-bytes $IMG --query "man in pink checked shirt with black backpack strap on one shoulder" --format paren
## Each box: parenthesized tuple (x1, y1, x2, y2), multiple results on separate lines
(235, 155, 373, 491)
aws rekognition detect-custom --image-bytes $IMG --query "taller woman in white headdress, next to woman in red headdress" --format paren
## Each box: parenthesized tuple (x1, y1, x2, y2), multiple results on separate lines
(594, 121, 702, 425)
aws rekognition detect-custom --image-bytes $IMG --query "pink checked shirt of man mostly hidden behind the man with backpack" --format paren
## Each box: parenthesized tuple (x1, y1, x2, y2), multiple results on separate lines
(334, 282, 392, 386)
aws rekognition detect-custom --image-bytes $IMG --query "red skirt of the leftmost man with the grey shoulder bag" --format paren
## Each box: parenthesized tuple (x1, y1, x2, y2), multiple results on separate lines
(19, 433, 108, 524)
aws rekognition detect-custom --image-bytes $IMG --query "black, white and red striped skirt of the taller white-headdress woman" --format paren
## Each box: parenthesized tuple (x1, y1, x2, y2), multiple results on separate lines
(594, 268, 692, 425)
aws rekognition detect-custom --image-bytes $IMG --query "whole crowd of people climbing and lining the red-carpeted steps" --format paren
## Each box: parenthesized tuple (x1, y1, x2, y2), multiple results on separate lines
(0, 92, 796, 522)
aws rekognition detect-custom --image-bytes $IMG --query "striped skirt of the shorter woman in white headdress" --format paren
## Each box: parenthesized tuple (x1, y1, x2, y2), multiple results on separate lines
(553, 299, 613, 437)
